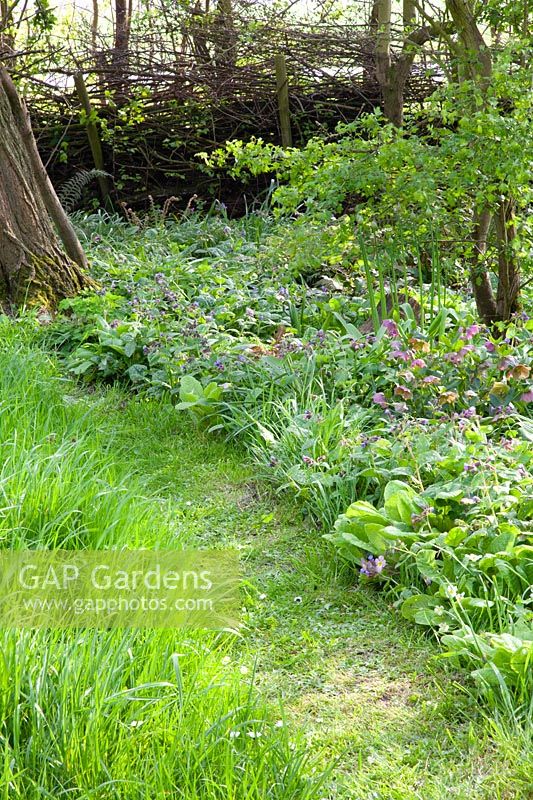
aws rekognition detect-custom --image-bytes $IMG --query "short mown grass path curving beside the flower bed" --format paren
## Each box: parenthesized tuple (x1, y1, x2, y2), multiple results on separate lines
(111, 400, 530, 800)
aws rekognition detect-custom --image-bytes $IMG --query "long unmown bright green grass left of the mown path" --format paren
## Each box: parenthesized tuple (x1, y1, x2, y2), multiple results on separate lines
(0, 320, 322, 800)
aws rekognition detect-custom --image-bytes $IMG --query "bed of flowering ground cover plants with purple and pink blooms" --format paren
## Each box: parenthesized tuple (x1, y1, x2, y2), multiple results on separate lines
(46, 208, 533, 724)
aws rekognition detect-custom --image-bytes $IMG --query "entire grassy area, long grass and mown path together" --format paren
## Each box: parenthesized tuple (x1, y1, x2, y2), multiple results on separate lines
(0, 323, 531, 800)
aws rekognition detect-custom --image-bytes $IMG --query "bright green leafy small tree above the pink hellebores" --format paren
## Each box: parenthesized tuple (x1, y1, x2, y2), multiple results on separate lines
(201, 50, 533, 323)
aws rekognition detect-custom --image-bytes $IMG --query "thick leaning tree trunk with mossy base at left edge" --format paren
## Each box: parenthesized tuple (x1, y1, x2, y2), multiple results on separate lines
(0, 65, 92, 310)
